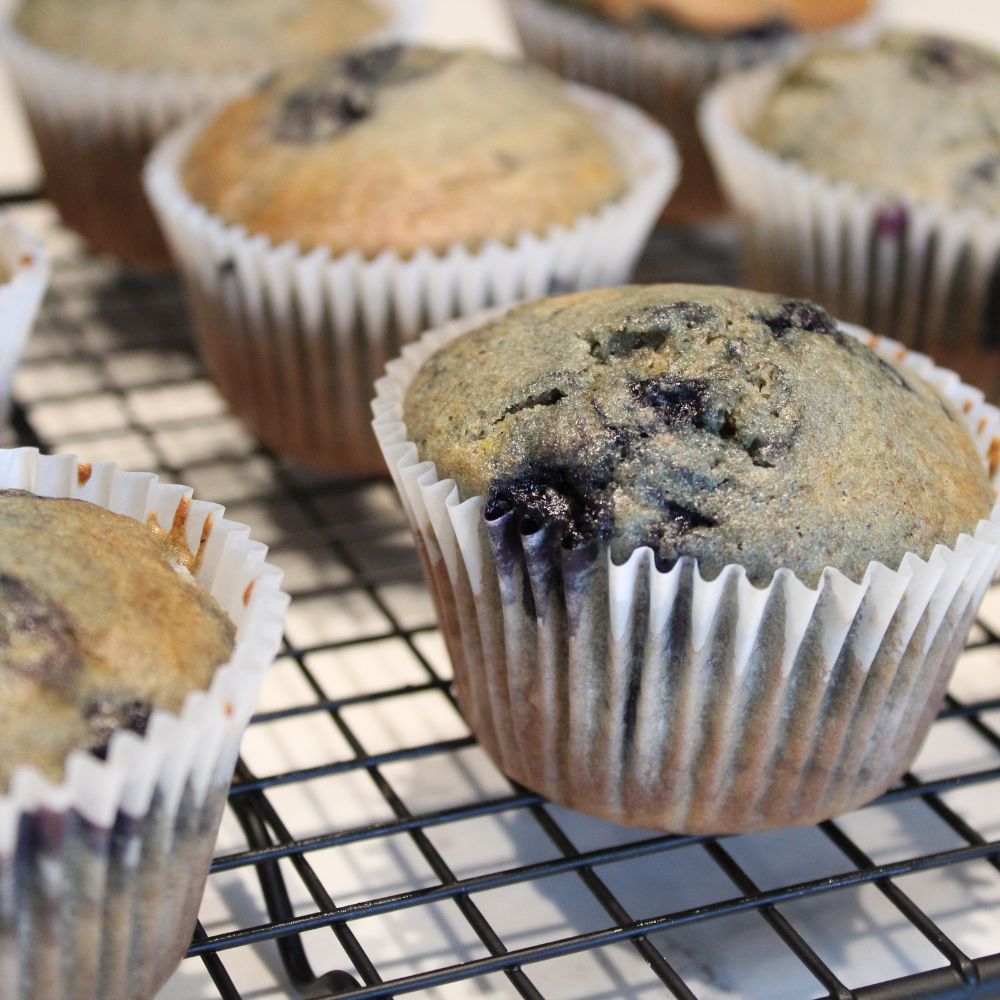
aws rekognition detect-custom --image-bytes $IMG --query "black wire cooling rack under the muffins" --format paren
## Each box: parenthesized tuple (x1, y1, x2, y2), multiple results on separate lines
(7, 203, 1000, 1000)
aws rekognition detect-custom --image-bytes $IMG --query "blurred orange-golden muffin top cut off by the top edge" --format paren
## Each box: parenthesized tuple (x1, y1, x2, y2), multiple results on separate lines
(564, 0, 871, 35)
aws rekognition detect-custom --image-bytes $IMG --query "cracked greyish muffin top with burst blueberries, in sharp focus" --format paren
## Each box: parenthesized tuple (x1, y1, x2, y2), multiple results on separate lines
(403, 285, 994, 586)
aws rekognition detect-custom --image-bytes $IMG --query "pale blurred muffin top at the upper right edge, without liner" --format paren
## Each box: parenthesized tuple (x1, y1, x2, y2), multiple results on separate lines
(752, 33, 1000, 213)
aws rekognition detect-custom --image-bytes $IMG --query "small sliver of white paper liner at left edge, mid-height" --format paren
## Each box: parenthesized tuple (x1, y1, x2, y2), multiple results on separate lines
(0, 215, 49, 433)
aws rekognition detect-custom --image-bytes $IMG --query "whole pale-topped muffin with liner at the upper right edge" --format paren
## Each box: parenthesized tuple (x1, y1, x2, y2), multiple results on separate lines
(701, 32, 1000, 398)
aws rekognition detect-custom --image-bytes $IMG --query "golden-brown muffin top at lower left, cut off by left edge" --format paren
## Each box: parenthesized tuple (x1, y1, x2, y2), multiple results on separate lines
(0, 490, 234, 791)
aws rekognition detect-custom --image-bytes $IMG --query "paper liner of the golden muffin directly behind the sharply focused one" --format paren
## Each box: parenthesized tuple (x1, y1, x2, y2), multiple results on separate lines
(146, 86, 678, 472)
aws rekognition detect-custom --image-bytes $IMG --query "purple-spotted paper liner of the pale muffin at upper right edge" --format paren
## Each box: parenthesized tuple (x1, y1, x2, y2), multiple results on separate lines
(700, 61, 1000, 398)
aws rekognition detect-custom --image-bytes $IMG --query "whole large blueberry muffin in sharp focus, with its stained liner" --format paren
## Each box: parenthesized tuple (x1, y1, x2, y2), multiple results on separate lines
(375, 285, 1000, 834)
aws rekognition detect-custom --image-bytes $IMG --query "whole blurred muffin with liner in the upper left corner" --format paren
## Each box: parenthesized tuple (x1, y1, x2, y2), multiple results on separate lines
(0, 0, 402, 267)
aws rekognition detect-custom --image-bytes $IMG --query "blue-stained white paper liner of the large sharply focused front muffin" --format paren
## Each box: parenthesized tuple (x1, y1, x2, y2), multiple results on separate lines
(373, 310, 1000, 833)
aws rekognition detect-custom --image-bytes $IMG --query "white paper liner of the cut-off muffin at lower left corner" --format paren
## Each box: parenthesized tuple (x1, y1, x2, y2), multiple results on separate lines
(0, 448, 288, 1000)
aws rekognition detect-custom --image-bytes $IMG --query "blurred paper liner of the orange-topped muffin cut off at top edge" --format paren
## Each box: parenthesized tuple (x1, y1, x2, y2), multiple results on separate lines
(509, 0, 881, 221)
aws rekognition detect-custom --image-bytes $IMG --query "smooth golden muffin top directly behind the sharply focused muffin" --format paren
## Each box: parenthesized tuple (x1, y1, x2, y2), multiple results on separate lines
(183, 45, 625, 256)
